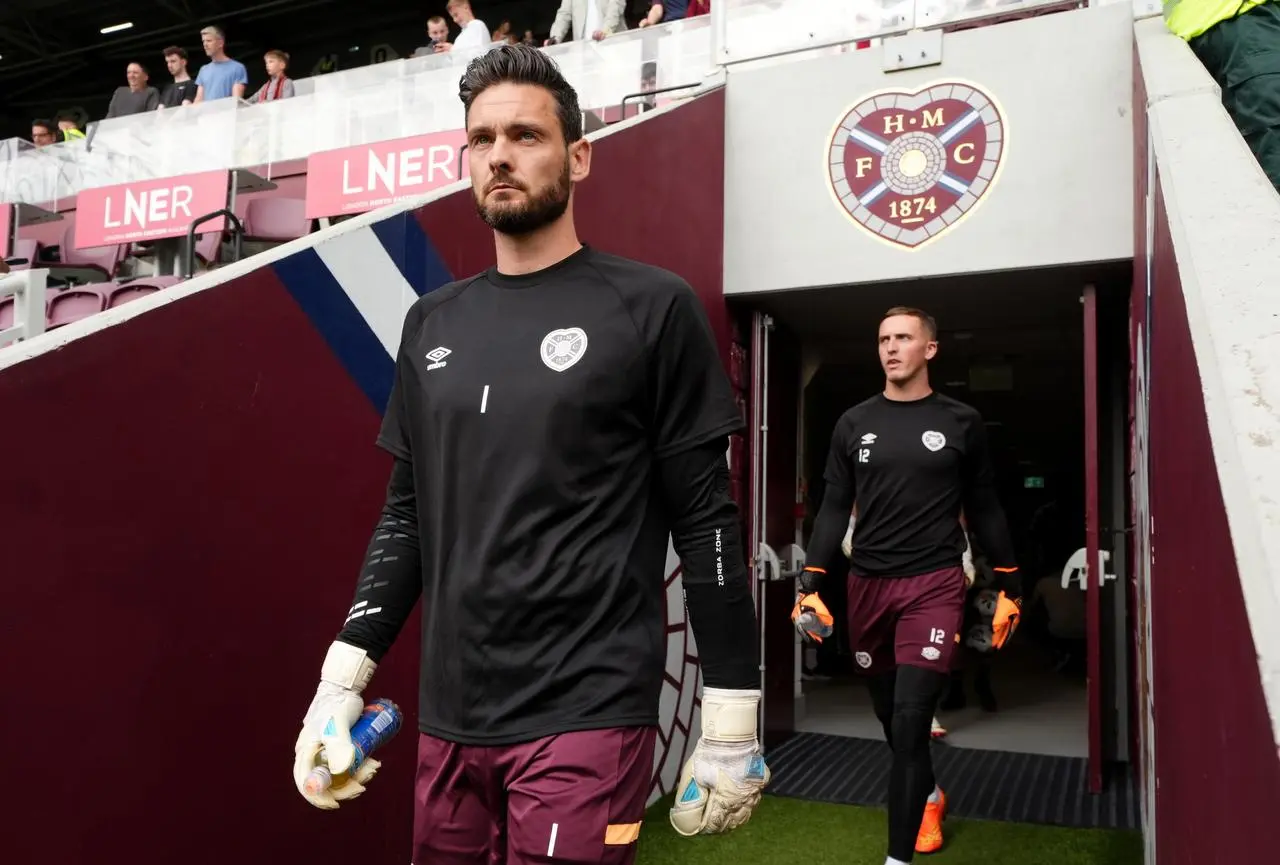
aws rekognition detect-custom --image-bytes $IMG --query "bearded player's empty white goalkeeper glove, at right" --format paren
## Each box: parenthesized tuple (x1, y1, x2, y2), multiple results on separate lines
(671, 688, 769, 836)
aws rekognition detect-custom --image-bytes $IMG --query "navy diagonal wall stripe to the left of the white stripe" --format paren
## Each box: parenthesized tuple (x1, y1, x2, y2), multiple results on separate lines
(271, 250, 396, 415)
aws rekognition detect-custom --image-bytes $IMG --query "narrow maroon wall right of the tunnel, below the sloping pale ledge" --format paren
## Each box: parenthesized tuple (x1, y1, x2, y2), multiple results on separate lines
(1148, 170, 1280, 865)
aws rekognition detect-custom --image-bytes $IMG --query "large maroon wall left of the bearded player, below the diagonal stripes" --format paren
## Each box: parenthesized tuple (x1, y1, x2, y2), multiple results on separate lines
(0, 269, 417, 865)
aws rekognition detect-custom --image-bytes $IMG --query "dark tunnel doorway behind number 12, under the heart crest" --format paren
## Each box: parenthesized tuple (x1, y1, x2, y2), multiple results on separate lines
(731, 262, 1133, 777)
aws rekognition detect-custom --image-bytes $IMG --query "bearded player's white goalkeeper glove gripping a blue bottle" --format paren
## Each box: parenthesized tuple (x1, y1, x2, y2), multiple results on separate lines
(293, 641, 381, 809)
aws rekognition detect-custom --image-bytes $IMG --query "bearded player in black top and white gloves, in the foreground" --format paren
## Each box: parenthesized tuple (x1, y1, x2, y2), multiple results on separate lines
(293, 45, 769, 865)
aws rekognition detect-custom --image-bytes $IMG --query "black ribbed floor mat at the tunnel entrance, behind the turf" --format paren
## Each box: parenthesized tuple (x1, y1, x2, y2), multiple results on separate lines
(765, 733, 1142, 829)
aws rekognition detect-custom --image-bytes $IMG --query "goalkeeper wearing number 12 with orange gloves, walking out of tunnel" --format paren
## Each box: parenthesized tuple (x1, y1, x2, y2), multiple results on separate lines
(792, 307, 1020, 865)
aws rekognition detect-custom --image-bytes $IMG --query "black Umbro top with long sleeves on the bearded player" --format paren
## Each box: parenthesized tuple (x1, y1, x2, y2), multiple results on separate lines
(339, 248, 759, 745)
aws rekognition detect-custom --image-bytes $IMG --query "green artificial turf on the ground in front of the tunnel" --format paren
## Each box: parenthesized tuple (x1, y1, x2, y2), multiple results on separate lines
(636, 796, 1142, 865)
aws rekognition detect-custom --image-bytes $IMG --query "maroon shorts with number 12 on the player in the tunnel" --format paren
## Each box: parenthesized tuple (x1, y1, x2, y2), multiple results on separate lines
(849, 567, 966, 674)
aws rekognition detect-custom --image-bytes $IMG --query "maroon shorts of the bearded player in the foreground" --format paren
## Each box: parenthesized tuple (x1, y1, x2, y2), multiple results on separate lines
(413, 727, 657, 865)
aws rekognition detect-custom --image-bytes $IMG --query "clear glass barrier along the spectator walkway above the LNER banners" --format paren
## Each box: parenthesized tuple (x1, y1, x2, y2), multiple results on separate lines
(0, 0, 1100, 206)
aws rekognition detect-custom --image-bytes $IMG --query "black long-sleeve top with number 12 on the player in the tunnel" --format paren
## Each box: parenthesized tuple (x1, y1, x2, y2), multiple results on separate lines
(808, 393, 1016, 588)
